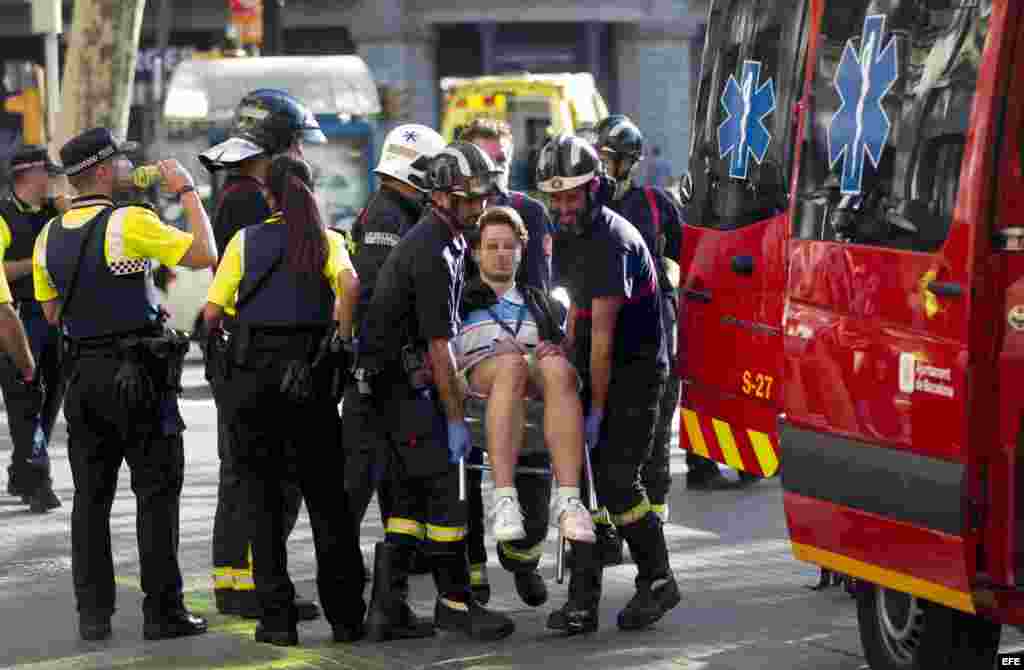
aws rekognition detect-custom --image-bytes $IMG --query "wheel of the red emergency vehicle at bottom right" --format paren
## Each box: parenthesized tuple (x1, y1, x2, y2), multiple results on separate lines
(857, 582, 1001, 670)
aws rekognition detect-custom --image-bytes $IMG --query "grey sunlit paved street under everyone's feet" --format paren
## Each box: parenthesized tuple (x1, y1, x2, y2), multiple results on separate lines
(0, 366, 1022, 670)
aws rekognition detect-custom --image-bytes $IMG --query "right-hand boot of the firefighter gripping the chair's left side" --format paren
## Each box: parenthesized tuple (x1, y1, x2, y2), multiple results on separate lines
(432, 546, 515, 641)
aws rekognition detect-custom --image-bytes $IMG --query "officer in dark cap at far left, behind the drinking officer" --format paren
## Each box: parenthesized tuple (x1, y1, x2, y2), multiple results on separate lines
(0, 146, 63, 513)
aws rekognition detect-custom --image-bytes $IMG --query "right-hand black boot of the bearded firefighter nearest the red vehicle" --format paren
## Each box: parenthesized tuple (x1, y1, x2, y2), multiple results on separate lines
(618, 511, 682, 630)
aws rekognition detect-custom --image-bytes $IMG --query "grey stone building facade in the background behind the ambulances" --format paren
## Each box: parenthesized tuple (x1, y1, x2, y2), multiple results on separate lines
(0, 0, 708, 186)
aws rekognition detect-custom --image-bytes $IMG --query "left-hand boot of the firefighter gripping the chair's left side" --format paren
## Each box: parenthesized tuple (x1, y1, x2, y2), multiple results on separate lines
(366, 542, 434, 642)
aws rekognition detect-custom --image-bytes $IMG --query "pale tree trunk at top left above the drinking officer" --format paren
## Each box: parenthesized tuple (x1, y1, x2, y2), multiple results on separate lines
(53, 0, 145, 148)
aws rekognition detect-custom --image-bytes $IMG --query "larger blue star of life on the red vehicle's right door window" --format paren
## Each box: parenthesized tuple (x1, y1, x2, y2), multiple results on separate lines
(828, 14, 899, 195)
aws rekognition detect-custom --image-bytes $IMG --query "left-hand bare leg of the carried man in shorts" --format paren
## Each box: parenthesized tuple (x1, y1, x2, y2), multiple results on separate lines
(470, 353, 529, 489)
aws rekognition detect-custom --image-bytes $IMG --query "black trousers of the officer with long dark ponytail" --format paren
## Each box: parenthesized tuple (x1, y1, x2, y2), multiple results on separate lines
(219, 348, 366, 630)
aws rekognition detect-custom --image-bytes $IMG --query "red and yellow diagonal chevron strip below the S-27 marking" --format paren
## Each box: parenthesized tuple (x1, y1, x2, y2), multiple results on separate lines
(679, 407, 778, 477)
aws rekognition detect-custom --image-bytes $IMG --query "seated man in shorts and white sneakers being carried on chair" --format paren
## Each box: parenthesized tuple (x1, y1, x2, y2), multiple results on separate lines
(455, 207, 595, 542)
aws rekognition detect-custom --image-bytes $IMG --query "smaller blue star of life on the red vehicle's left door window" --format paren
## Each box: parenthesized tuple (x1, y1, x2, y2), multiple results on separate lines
(718, 60, 775, 179)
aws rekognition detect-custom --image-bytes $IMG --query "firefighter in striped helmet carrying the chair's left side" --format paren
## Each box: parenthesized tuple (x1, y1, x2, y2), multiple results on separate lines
(356, 141, 515, 639)
